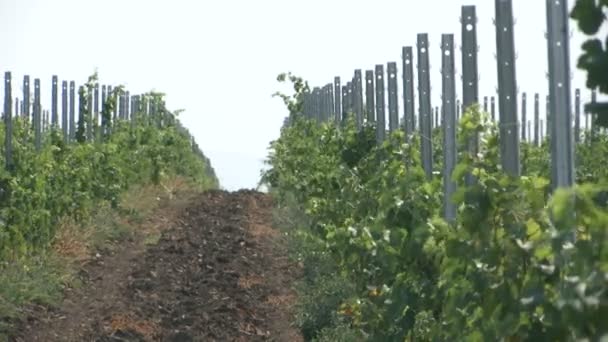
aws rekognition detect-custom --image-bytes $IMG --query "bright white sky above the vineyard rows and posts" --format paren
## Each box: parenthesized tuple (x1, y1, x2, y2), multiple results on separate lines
(0, 0, 600, 190)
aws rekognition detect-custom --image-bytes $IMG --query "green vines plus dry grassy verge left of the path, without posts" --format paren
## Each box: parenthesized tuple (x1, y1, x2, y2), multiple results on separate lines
(0, 73, 219, 340)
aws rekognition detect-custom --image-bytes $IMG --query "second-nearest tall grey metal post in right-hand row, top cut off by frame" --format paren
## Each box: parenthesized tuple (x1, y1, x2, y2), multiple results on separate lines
(495, 0, 520, 176)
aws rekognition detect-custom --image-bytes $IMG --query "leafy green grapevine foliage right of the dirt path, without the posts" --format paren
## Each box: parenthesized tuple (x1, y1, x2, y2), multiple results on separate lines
(263, 77, 608, 341)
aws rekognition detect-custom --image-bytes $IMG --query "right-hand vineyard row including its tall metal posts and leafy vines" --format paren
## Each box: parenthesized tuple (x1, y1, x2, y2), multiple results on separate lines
(262, 1, 608, 341)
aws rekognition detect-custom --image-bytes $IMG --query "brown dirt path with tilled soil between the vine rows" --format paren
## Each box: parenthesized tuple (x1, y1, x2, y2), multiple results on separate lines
(15, 191, 302, 342)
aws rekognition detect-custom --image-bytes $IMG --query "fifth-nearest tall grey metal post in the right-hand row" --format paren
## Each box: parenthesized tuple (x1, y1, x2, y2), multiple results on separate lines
(417, 33, 433, 179)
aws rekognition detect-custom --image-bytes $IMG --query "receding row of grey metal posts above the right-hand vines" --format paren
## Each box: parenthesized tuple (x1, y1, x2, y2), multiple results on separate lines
(303, 0, 596, 221)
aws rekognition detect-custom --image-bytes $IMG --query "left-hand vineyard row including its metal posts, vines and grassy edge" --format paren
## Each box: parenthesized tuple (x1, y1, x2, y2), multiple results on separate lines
(0, 73, 219, 340)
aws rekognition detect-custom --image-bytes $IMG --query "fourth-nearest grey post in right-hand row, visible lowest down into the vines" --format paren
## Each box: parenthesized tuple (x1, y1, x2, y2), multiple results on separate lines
(441, 34, 456, 222)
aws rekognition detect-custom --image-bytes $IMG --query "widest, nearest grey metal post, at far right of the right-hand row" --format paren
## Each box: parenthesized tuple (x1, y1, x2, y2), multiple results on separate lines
(546, 0, 575, 189)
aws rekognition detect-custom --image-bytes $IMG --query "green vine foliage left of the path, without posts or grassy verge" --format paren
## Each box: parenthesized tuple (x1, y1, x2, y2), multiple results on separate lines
(0, 74, 218, 259)
